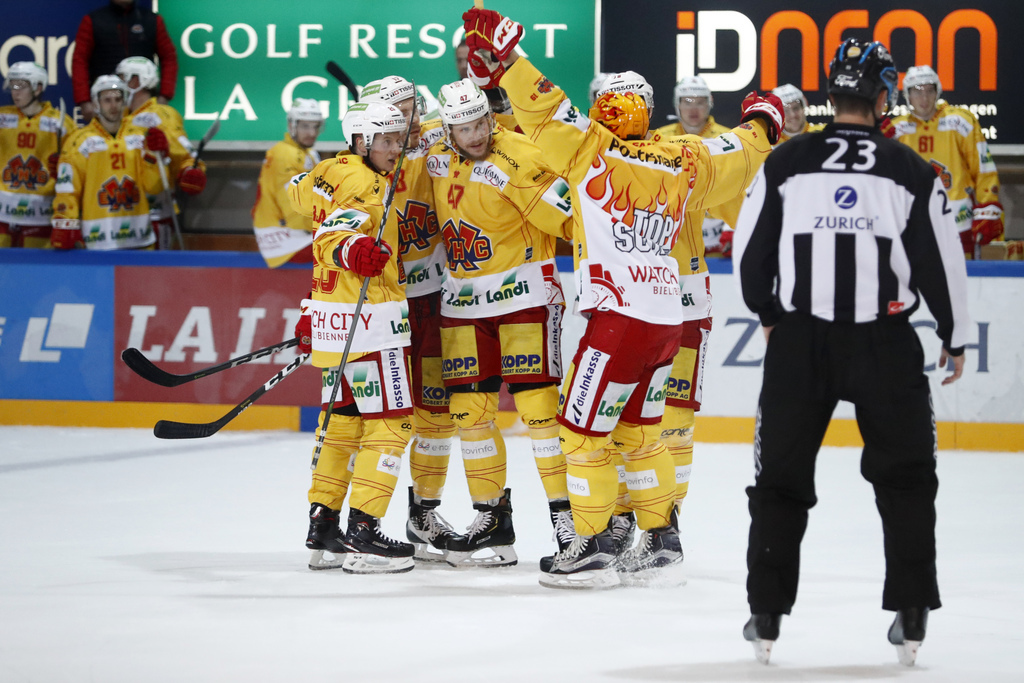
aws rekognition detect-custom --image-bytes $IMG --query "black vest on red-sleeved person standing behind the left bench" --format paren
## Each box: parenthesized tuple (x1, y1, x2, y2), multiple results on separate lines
(89, 2, 157, 83)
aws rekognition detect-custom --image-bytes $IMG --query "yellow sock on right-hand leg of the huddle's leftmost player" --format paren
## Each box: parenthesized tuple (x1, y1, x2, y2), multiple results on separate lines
(348, 417, 412, 517)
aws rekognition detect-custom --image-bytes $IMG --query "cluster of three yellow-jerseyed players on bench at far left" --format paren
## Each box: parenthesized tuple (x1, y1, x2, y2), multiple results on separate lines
(0, 56, 206, 250)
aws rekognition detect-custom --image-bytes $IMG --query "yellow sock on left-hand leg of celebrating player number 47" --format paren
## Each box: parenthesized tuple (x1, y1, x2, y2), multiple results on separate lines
(449, 391, 507, 503)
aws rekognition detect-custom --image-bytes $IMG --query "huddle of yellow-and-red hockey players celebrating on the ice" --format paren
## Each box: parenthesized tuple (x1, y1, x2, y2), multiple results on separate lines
(289, 9, 783, 588)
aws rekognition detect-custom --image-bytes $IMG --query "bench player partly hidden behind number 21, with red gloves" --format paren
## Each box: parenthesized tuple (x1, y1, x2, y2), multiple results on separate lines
(115, 56, 206, 249)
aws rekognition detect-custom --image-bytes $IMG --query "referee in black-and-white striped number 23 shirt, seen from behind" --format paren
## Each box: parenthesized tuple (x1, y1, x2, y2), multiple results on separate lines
(733, 39, 969, 664)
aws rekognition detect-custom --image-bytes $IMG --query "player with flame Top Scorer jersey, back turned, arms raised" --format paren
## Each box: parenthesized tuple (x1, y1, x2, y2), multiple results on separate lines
(463, 9, 782, 588)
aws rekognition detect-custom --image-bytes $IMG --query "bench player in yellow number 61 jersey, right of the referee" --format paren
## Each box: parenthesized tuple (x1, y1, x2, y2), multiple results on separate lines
(893, 66, 1002, 256)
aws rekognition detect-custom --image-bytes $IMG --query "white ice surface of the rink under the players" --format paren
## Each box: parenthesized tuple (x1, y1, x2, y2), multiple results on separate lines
(0, 427, 1024, 683)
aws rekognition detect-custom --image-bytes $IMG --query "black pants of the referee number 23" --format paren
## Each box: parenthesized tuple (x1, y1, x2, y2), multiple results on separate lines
(746, 313, 941, 614)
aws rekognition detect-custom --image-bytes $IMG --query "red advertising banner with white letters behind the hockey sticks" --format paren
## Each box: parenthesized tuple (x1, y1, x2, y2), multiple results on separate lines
(114, 266, 321, 405)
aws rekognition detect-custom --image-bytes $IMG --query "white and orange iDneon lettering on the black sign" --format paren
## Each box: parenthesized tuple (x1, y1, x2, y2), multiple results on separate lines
(675, 5, 998, 93)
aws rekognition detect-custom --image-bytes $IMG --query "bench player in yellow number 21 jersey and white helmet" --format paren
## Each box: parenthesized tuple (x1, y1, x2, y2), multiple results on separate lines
(50, 75, 166, 251)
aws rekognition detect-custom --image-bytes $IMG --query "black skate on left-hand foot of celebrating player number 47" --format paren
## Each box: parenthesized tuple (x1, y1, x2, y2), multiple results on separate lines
(444, 488, 519, 567)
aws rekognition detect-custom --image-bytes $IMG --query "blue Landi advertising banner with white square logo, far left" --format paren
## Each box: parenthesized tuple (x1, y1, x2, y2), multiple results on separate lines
(0, 263, 114, 400)
